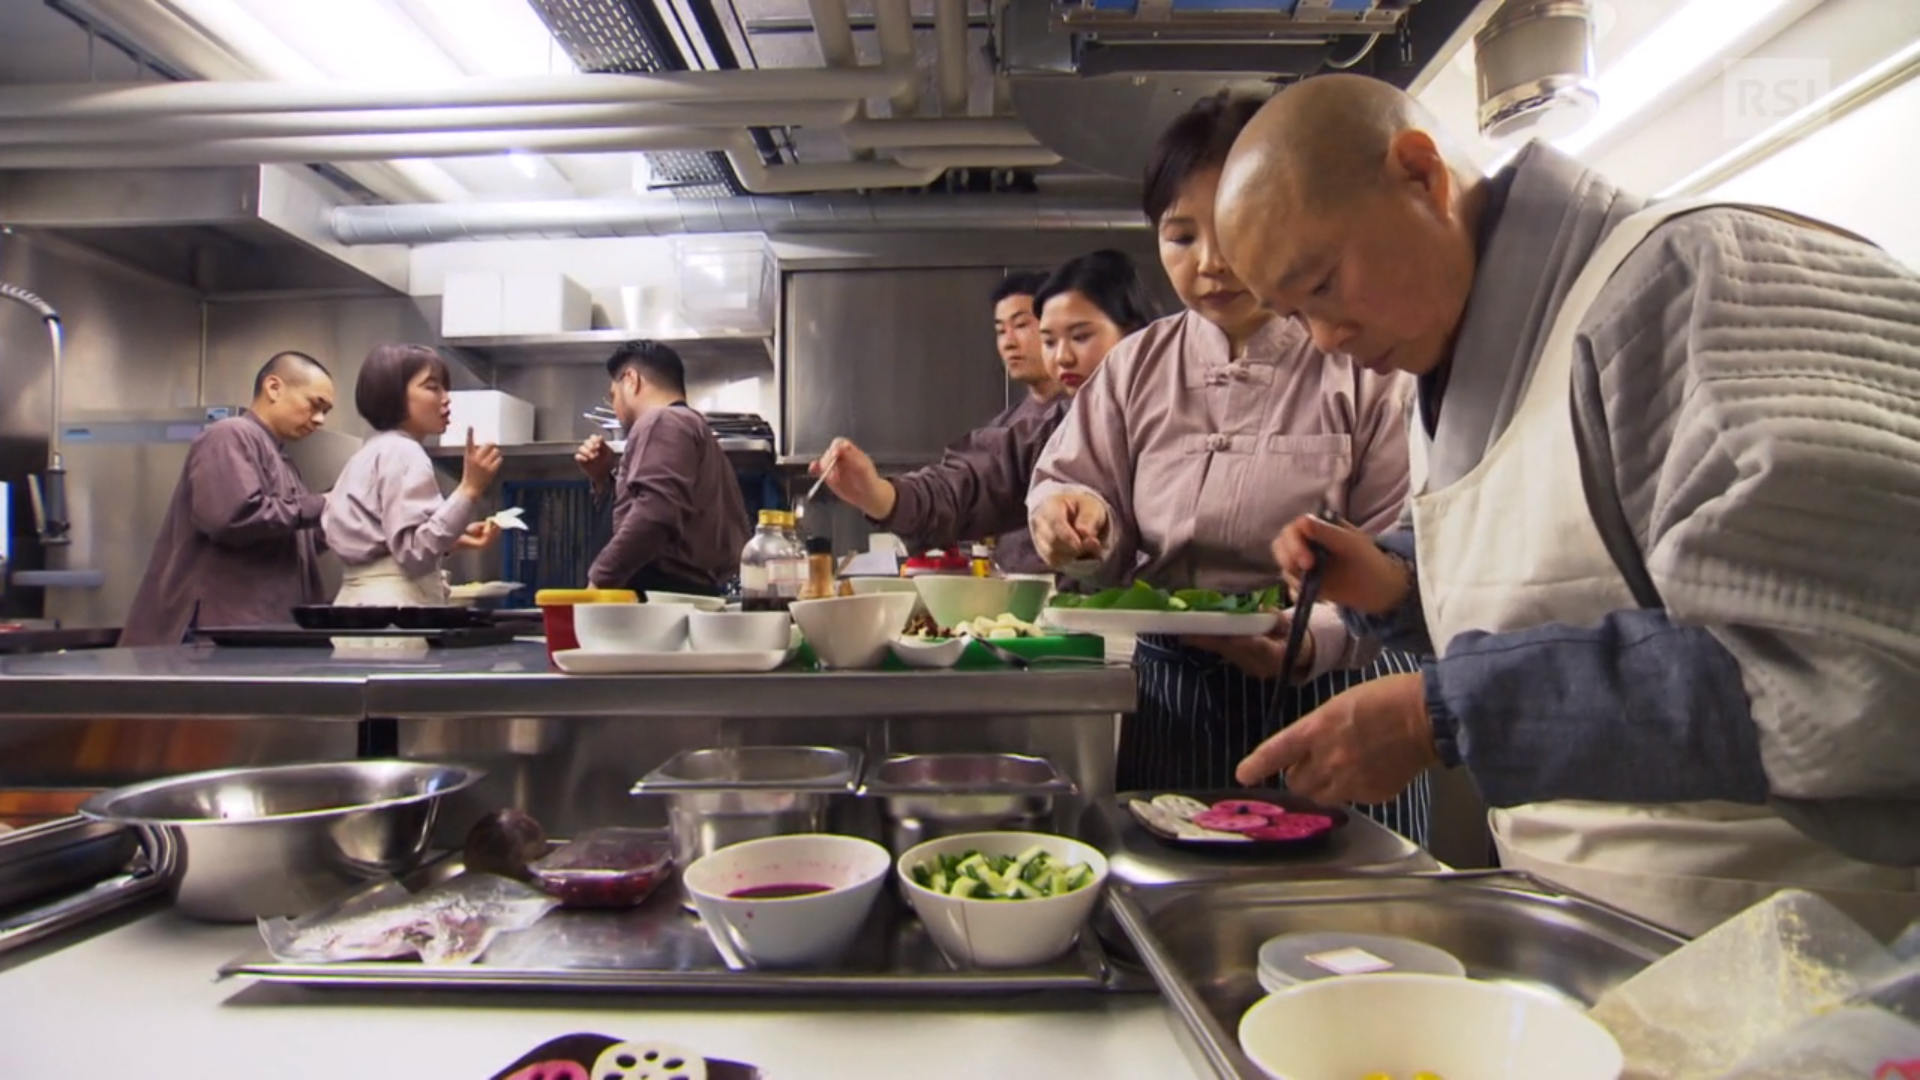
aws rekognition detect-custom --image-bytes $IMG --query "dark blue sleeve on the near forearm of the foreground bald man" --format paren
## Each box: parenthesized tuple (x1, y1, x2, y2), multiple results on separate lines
(1425, 609, 1768, 807)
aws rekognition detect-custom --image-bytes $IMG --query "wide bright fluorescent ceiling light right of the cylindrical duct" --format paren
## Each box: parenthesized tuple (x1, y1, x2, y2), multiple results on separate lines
(1553, 0, 1789, 154)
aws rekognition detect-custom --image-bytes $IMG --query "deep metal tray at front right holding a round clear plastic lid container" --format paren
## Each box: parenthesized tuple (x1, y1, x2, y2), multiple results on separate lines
(1108, 871, 1682, 1080)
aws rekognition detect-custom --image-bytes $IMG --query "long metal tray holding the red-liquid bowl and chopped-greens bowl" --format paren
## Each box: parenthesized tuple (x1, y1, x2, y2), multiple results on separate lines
(221, 855, 1154, 997)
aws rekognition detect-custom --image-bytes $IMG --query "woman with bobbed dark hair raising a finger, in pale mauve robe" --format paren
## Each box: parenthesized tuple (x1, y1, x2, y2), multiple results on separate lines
(321, 346, 499, 607)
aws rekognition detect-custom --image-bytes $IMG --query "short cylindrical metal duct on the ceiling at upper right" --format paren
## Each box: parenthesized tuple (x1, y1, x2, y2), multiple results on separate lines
(1473, 0, 1599, 144)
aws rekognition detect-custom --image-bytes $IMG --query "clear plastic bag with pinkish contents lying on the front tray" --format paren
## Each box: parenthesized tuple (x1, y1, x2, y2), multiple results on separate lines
(259, 874, 559, 967)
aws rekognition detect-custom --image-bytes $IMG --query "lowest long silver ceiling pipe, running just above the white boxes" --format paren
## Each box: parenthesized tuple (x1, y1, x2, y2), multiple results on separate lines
(332, 194, 1146, 246)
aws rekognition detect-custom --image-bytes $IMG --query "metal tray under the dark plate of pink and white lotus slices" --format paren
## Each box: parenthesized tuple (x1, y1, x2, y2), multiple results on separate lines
(1077, 792, 1446, 886)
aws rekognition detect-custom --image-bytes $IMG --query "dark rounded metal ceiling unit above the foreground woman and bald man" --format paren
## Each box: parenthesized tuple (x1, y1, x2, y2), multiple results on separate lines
(995, 0, 1413, 179)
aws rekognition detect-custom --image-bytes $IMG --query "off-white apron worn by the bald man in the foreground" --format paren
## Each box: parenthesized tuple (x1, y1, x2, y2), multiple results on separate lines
(1413, 200, 1920, 936)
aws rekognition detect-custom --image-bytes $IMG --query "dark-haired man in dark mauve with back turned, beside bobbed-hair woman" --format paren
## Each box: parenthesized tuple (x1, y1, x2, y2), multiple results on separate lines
(574, 342, 753, 596)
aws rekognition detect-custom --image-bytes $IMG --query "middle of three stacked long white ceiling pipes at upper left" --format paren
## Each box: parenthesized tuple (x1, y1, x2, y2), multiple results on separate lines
(0, 100, 858, 146)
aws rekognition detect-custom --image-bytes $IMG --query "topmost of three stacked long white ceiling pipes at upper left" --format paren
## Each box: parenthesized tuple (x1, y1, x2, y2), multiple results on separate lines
(0, 67, 920, 121)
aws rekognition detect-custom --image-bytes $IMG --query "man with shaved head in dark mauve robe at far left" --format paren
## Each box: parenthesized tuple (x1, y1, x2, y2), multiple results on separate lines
(119, 352, 334, 648)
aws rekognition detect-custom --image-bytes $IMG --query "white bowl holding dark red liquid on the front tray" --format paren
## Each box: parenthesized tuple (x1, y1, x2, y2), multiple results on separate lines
(682, 832, 891, 967)
